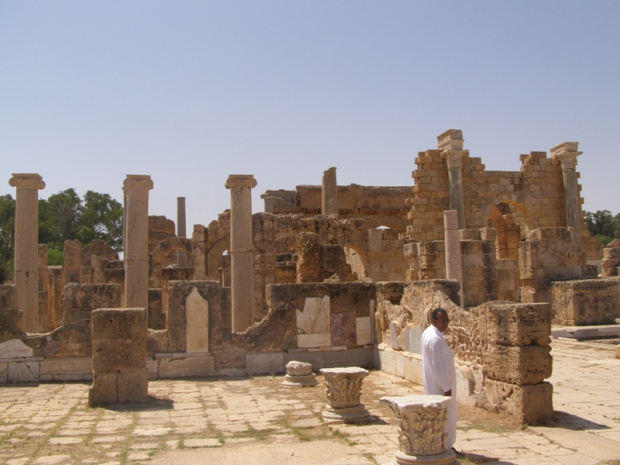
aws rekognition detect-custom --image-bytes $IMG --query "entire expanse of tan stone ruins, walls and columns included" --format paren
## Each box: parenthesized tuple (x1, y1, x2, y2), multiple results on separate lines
(0, 130, 620, 423)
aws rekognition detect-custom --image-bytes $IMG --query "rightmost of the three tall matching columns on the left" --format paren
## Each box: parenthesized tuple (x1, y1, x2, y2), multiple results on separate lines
(226, 174, 256, 333)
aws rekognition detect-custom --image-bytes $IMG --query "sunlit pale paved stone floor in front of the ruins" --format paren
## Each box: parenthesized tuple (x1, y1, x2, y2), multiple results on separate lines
(0, 340, 620, 465)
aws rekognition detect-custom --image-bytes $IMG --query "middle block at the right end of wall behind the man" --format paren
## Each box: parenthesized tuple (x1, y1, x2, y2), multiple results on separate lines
(483, 344, 552, 386)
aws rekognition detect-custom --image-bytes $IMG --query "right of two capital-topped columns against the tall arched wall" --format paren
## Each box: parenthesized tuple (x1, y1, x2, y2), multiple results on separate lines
(551, 142, 583, 242)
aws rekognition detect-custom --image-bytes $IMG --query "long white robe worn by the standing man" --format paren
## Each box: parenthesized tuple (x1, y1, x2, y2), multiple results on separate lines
(422, 325, 456, 449)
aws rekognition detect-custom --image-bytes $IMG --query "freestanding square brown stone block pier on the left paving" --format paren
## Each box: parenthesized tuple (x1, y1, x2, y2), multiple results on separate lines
(88, 308, 148, 406)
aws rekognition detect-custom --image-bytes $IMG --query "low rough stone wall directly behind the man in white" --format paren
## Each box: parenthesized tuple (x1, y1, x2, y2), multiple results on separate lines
(375, 280, 553, 424)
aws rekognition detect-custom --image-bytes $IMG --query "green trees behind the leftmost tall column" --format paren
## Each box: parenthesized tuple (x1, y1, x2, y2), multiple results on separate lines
(0, 188, 123, 283)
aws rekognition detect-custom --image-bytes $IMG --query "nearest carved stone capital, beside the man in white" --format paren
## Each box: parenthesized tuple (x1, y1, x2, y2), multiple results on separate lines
(379, 395, 459, 465)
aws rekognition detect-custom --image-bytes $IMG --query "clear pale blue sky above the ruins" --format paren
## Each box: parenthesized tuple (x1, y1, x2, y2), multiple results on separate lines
(0, 0, 620, 230)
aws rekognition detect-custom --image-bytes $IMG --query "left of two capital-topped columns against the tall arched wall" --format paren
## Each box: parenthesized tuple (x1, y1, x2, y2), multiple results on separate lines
(437, 129, 465, 229)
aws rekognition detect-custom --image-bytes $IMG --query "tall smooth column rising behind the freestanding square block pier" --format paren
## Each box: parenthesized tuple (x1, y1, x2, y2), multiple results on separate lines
(123, 174, 153, 309)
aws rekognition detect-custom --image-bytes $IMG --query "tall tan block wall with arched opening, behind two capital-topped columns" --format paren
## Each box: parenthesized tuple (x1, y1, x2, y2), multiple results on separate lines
(407, 138, 601, 259)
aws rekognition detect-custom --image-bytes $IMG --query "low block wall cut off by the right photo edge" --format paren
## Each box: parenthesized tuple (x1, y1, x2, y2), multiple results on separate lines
(550, 279, 620, 326)
